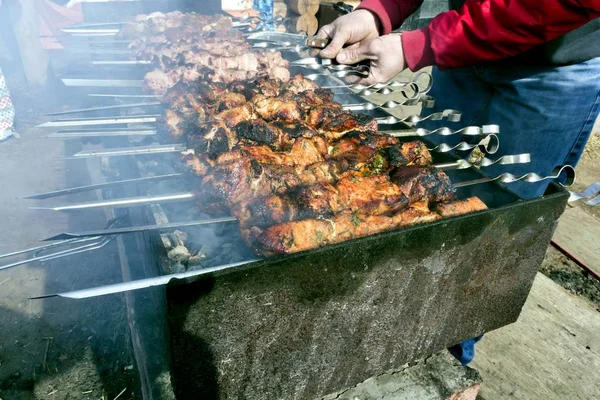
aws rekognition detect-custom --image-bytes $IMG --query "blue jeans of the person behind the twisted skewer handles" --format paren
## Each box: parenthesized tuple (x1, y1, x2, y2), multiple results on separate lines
(420, 58, 600, 199)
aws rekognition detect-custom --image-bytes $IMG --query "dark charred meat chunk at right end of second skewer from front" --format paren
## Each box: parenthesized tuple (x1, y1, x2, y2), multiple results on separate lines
(392, 166, 456, 204)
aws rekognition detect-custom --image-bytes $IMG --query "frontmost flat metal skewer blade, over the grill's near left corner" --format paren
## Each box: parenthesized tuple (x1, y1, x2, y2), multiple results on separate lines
(29, 258, 263, 300)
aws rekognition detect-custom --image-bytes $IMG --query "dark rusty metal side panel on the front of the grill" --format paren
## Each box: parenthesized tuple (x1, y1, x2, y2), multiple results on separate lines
(167, 188, 566, 399)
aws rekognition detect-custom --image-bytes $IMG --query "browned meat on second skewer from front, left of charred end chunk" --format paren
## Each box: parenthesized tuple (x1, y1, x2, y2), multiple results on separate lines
(239, 174, 408, 227)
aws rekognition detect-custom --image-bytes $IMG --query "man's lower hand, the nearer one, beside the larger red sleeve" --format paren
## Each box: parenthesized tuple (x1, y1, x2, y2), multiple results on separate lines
(336, 34, 406, 85)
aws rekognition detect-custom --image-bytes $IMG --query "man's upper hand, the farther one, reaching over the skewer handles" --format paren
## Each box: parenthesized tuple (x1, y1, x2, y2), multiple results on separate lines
(315, 10, 380, 58)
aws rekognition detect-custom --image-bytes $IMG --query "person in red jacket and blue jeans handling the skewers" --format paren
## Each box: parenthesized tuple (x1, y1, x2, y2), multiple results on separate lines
(316, 0, 600, 365)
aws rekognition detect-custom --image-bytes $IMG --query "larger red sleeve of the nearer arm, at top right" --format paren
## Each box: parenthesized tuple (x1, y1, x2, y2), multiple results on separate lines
(400, 0, 600, 71)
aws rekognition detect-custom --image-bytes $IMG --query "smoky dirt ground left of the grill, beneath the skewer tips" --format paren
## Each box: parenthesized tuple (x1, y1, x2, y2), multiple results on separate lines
(0, 69, 137, 400)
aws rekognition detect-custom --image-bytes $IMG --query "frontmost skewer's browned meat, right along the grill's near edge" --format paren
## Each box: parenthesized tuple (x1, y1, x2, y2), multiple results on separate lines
(253, 206, 441, 256)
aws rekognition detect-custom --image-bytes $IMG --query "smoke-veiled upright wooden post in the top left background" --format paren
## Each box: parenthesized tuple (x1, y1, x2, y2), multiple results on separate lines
(13, 0, 50, 86)
